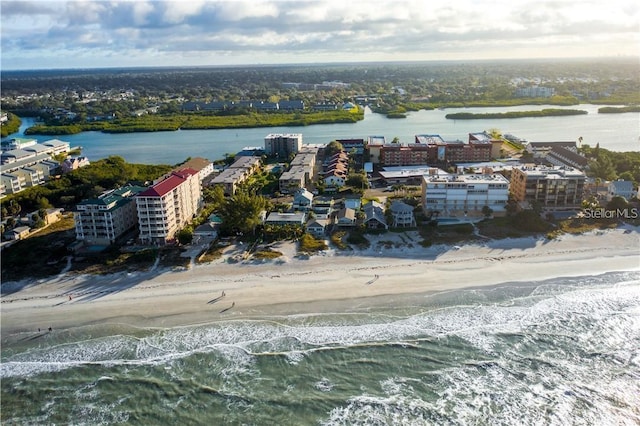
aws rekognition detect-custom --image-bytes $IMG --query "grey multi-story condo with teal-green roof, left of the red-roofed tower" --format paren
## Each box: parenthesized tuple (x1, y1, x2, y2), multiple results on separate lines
(73, 185, 145, 246)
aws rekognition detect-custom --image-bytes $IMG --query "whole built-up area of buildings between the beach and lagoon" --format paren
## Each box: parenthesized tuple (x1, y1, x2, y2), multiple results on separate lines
(1, 128, 637, 272)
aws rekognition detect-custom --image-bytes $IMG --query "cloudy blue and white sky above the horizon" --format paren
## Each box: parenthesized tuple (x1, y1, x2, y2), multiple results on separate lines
(0, 0, 640, 70)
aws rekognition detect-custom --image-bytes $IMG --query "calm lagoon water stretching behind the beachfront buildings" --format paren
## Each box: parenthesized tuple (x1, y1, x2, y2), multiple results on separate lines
(10, 104, 640, 164)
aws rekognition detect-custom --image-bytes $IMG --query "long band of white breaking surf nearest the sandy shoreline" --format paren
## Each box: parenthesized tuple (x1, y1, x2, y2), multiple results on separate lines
(0, 274, 640, 378)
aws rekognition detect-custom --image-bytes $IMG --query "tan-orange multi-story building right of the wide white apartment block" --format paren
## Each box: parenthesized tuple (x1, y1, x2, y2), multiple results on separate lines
(511, 166, 586, 209)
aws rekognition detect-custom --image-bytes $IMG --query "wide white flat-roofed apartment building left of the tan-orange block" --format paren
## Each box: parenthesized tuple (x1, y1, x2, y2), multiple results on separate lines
(422, 174, 509, 217)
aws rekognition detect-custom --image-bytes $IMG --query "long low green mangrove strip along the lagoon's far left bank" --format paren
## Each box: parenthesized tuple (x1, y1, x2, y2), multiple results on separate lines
(25, 108, 364, 135)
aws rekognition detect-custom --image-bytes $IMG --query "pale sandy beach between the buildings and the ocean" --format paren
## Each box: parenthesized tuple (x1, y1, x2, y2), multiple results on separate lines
(1, 228, 640, 343)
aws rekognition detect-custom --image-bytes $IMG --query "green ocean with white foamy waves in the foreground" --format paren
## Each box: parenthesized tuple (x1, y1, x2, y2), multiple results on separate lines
(0, 271, 640, 425)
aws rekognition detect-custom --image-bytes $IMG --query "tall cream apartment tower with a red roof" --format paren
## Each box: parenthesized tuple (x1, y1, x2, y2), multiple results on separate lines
(136, 169, 202, 245)
